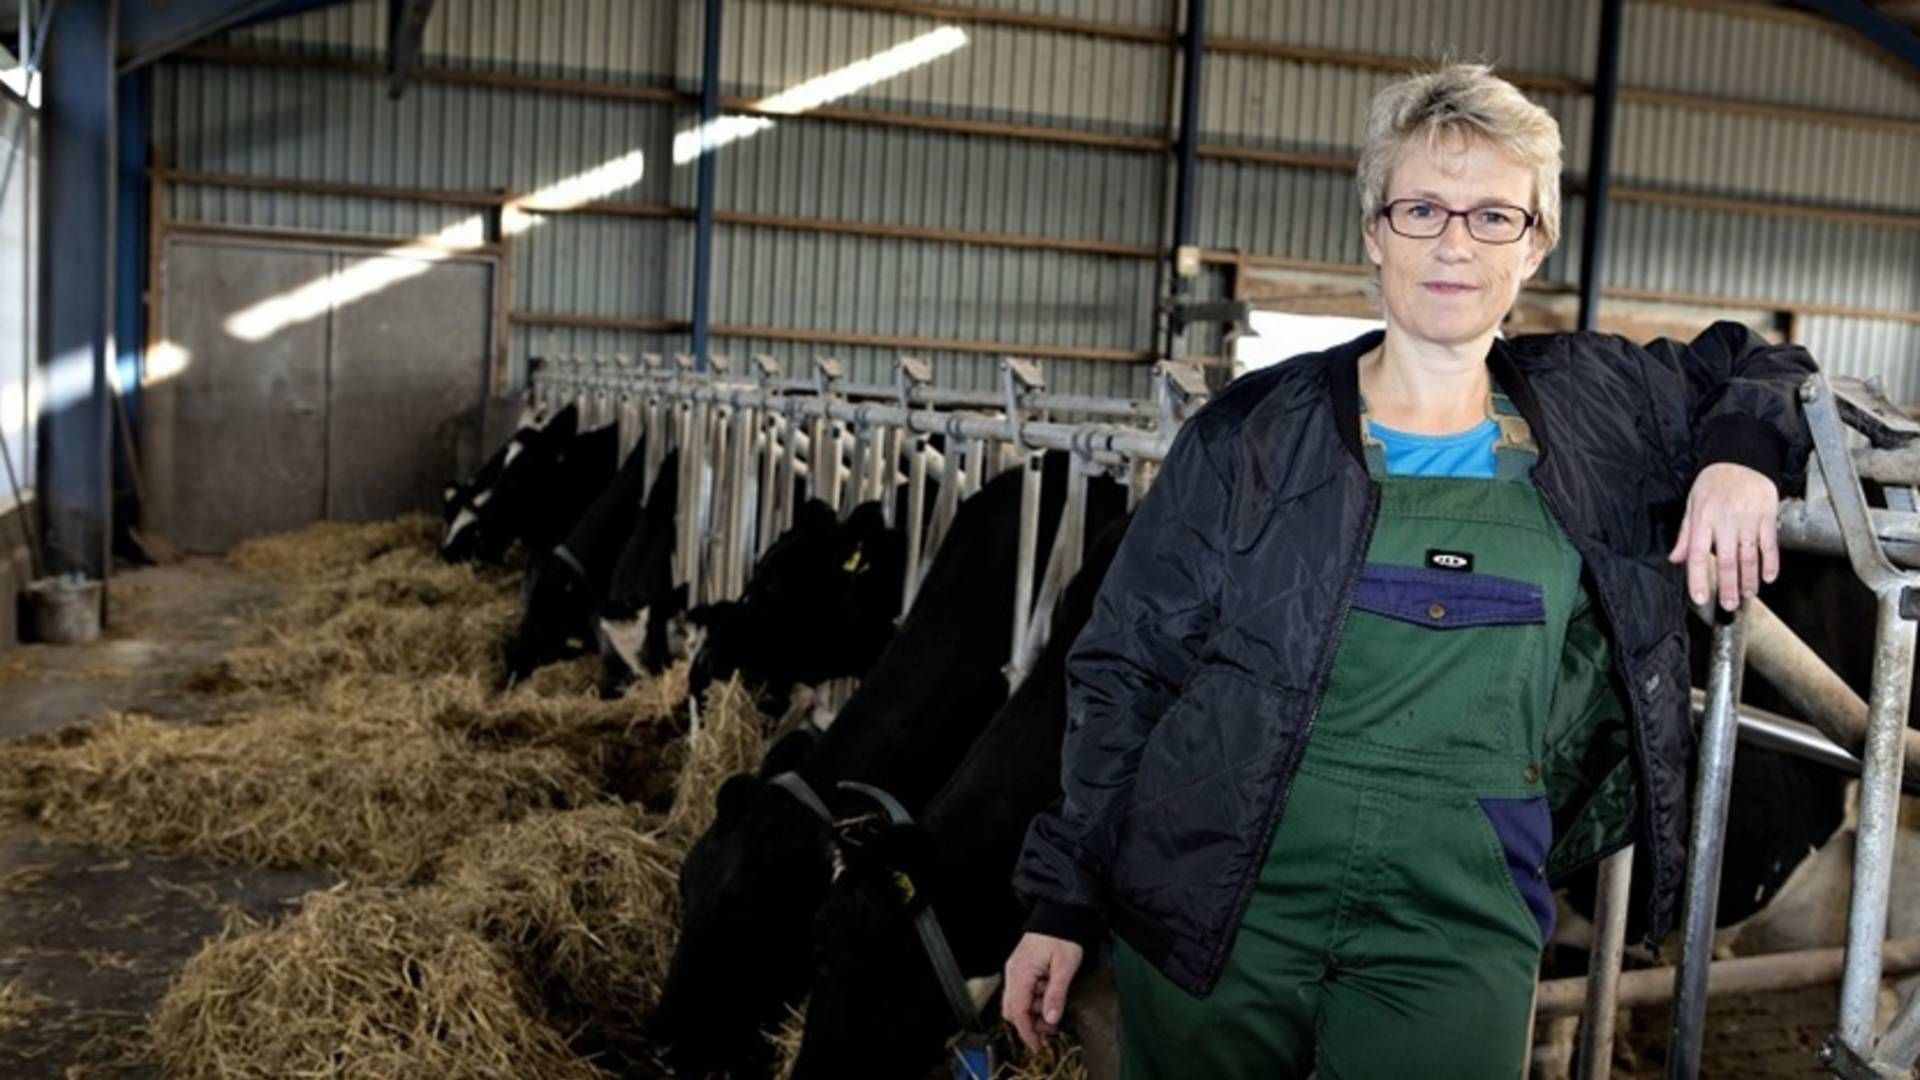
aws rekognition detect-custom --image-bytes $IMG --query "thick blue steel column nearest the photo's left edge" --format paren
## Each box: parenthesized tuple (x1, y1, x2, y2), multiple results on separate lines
(38, 0, 119, 578)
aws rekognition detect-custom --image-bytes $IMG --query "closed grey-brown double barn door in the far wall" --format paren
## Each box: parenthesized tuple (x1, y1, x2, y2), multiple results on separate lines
(142, 233, 495, 552)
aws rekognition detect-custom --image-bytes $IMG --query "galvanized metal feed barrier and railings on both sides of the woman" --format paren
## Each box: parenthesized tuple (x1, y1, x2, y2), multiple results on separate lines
(532, 356, 1920, 1080)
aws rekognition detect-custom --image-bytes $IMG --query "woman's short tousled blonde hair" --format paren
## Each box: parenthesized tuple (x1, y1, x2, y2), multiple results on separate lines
(1357, 63, 1561, 252)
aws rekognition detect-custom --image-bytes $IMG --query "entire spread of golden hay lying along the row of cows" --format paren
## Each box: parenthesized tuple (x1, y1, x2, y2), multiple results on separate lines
(16, 517, 766, 1080)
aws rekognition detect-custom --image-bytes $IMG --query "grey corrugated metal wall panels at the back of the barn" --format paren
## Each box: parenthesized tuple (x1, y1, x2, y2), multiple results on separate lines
(156, 0, 1920, 400)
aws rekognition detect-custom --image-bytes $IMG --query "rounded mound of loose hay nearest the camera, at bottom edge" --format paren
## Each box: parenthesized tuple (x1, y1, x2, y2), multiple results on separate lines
(152, 890, 603, 1080)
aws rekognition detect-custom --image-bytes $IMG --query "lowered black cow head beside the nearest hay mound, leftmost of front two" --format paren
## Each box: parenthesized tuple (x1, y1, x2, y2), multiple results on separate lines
(647, 757, 833, 1076)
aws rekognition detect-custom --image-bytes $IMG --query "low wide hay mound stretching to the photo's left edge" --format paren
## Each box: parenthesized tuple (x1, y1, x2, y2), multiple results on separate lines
(0, 707, 597, 882)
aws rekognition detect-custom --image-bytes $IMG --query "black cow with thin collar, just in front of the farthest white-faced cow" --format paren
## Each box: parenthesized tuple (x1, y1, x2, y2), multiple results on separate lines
(505, 440, 647, 682)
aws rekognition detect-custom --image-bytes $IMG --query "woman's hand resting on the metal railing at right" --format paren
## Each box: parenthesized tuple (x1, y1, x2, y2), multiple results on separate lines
(1667, 461, 1780, 611)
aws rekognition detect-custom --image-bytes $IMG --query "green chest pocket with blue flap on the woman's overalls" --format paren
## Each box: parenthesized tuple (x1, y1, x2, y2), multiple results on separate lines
(1321, 563, 1548, 761)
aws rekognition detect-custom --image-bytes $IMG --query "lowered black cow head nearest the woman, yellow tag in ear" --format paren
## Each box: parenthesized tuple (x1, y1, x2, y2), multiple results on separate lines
(793, 824, 958, 1080)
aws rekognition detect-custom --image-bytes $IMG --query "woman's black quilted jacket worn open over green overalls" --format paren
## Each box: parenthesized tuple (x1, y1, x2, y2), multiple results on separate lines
(1014, 323, 1814, 994)
